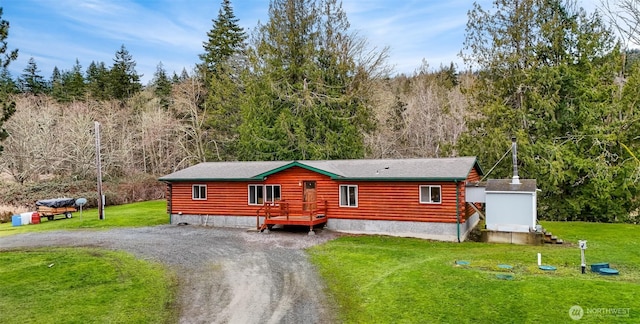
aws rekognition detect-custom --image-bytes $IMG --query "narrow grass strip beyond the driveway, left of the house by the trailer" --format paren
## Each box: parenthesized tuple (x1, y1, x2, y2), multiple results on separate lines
(0, 200, 169, 237)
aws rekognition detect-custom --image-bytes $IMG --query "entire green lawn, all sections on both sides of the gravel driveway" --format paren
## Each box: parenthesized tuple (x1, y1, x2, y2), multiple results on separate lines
(0, 201, 640, 323)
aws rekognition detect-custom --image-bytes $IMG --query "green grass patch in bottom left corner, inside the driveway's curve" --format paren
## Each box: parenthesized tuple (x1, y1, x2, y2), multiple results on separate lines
(0, 248, 177, 323)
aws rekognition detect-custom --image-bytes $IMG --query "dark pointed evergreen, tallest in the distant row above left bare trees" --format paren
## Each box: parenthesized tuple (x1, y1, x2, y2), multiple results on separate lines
(107, 45, 142, 100)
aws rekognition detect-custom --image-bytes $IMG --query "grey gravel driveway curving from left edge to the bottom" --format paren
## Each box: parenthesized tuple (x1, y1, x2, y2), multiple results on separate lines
(0, 225, 338, 324)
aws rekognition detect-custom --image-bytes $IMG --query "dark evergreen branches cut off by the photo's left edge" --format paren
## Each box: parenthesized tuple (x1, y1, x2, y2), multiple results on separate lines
(0, 7, 18, 152)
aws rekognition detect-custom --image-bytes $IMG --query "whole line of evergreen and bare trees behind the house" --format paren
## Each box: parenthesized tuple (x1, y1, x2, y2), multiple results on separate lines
(0, 0, 640, 222)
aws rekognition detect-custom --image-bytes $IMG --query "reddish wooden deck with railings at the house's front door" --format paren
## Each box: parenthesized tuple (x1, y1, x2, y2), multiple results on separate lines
(256, 200, 327, 234)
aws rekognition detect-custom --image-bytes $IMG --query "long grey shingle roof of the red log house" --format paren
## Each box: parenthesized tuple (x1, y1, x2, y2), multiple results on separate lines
(160, 157, 482, 182)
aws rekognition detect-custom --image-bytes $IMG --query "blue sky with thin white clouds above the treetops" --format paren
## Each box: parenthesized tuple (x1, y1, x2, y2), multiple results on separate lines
(0, 0, 598, 83)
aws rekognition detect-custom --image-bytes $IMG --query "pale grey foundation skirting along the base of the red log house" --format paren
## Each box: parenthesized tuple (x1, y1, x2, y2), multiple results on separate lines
(171, 213, 480, 242)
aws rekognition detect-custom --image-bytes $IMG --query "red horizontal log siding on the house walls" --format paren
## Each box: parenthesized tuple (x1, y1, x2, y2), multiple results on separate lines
(167, 166, 480, 223)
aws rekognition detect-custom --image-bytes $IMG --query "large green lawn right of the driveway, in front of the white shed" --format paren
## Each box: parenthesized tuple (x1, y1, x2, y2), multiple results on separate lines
(308, 222, 640, 323)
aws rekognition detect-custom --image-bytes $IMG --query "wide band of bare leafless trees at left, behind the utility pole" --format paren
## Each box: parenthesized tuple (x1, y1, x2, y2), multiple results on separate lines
(0, 88, 194, 183)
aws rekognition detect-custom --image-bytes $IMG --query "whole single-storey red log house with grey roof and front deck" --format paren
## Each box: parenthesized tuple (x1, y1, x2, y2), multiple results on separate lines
(160, 157, 482, 241)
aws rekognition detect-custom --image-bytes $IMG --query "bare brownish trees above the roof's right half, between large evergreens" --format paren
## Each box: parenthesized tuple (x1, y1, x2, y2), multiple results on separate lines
(365, 65, 473, 158)
